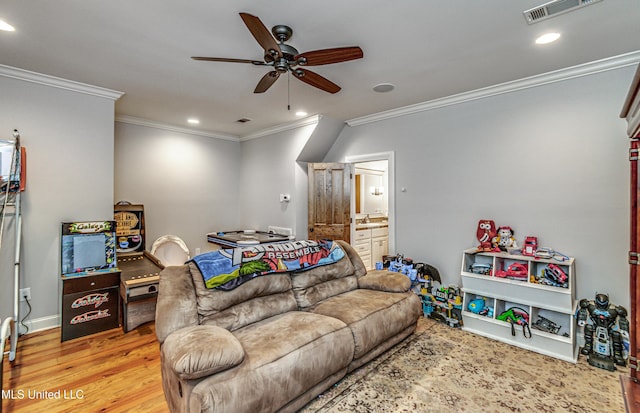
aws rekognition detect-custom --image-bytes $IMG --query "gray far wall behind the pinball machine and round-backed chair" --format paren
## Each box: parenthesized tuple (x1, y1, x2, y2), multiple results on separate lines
(114, 122, 243, 255)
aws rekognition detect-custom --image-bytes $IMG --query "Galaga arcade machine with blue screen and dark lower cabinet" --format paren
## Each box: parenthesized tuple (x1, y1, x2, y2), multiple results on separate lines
(60, 221, 120, 341)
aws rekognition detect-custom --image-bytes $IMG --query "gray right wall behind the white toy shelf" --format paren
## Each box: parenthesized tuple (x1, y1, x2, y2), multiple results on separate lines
(325, 67, 635, 306)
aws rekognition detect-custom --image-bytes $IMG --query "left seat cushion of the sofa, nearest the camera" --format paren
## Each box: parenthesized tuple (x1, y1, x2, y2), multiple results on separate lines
(191, 311, 354, 413)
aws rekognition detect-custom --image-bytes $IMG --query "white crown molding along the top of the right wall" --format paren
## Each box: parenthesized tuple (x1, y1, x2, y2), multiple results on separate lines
(345, 50, 640, 126)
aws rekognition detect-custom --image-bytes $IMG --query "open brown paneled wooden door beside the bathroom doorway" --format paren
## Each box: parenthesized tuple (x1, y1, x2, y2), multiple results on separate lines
(307, 163, 352, 242)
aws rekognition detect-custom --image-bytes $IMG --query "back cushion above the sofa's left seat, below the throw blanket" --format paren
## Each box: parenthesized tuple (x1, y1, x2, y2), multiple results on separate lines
(189, 262, 297, 331)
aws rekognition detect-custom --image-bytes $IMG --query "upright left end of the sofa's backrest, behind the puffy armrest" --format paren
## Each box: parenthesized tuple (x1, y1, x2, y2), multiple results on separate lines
(156, 265, 199, 344)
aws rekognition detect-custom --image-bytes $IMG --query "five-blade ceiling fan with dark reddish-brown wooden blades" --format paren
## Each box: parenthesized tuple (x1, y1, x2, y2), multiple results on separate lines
(192, 13, 363, 93)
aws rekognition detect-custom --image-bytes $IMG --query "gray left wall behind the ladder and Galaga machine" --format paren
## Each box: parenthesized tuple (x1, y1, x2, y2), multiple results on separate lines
(0, 75, 114, 330)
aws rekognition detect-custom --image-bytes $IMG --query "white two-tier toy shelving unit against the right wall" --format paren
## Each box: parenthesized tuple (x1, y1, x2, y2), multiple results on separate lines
(461, 248, 578, 363)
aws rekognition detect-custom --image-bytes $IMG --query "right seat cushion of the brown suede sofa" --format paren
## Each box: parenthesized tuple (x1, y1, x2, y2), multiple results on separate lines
(309, 289, 422, 359)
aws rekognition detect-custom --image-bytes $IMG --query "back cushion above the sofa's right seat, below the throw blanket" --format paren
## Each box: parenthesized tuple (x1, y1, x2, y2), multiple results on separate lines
(291, 251, 358, 310)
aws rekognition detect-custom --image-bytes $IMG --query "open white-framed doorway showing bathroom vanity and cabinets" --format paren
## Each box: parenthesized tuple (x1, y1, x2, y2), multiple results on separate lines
(345, 152, 395, 269)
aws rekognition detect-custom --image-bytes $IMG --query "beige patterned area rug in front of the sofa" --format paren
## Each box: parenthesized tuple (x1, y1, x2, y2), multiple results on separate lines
(301, 319, 628, 413)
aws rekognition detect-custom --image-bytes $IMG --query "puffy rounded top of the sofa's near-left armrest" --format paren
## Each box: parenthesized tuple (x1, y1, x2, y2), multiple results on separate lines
(162, 325, 244, 380)
